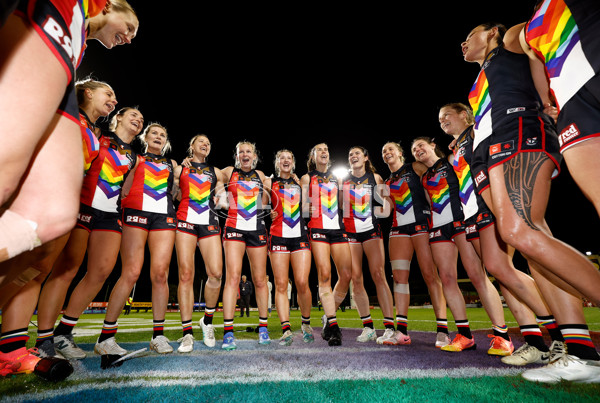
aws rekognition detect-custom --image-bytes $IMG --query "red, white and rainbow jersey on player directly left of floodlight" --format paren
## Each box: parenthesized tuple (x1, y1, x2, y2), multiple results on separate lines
(308, 170, 344, 230)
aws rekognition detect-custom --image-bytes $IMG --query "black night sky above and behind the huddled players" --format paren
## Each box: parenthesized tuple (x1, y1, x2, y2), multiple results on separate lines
(78, 0, 598, 301)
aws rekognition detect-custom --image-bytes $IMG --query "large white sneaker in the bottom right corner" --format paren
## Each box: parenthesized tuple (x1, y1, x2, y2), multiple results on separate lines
(521, 354, 600, 383)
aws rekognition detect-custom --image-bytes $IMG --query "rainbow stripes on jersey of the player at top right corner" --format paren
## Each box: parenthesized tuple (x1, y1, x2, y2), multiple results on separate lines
(527, 1, 579, 78)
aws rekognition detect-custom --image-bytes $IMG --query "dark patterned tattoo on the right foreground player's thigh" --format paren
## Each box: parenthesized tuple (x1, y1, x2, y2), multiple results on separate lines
(504, 152, 548, 231)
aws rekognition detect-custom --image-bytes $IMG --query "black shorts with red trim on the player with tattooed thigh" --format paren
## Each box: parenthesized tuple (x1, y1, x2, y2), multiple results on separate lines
(488, 114, 562, 177)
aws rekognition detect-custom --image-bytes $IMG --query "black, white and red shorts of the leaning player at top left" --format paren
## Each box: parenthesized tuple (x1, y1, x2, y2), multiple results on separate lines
(15, 0, 86, 122)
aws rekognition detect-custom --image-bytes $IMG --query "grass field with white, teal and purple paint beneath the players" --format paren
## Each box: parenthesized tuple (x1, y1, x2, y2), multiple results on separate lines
(0, 308, 600, 402)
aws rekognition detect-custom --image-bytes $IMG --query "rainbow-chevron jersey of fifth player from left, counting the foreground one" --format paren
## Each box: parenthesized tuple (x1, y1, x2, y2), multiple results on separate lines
(177, 162, 219, 225)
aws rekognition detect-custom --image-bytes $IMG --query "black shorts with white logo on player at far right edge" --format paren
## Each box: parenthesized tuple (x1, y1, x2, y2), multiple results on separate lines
(556, 74, 600, 153)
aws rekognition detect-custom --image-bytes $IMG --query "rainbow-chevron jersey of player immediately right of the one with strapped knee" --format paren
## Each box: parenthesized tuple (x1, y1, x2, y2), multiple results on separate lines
(422, 158, 464, 228)
